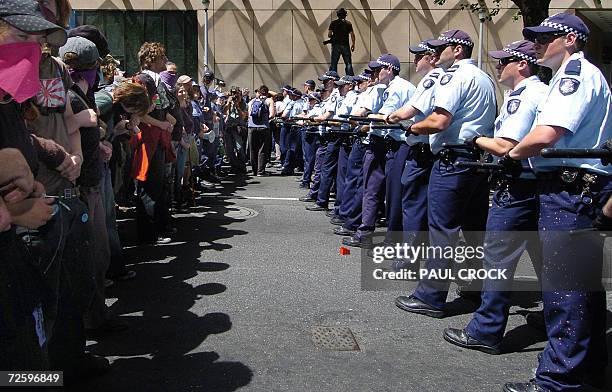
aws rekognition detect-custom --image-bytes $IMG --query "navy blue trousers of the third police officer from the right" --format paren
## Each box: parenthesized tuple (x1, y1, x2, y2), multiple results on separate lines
(414, 159, 489, 309)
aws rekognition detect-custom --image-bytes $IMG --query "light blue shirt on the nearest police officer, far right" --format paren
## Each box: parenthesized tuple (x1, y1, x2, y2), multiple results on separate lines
(529, 52, 612, 175)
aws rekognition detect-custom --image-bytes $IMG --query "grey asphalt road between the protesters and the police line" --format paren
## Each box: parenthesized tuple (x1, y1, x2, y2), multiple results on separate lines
(71, 171, 612, 392)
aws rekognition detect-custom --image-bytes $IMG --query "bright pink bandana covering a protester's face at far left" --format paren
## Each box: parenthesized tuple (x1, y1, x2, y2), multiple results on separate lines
(0, 42, 41, 103)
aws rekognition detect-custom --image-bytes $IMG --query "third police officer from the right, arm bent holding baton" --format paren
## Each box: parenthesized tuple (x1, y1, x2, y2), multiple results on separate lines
(395, 30, 496, 317)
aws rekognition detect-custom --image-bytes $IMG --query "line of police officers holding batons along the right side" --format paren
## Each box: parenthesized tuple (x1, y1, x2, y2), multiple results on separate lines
(283, 13, 612, 392)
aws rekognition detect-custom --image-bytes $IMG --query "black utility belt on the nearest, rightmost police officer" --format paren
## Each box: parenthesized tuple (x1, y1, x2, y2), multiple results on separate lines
(536, 167, 610, 204)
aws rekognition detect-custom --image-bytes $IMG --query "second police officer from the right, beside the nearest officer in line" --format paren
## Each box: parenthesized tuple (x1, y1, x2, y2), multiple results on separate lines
(444, 40, 548, 354)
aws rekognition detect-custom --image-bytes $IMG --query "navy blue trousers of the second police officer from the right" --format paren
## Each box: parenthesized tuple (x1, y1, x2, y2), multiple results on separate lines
(467, 179, 542, 346)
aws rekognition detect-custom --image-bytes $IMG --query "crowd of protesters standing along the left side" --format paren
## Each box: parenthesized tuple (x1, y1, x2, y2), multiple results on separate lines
(0, 0, 298, 383)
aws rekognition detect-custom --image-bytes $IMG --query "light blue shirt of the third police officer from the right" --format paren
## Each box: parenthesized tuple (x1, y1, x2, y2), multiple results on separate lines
(429, 59, 497, 154)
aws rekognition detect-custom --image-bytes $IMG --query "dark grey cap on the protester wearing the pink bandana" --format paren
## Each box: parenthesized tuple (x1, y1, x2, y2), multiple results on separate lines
(0, 0, 67, 47)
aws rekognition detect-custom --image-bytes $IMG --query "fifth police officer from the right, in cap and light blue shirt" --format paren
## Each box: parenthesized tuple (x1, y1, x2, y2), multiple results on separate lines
(342, 53, 416, 247)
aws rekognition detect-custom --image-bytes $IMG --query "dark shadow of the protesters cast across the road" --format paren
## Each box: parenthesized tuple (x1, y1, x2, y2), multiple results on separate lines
(69, 175, 253, 392)
